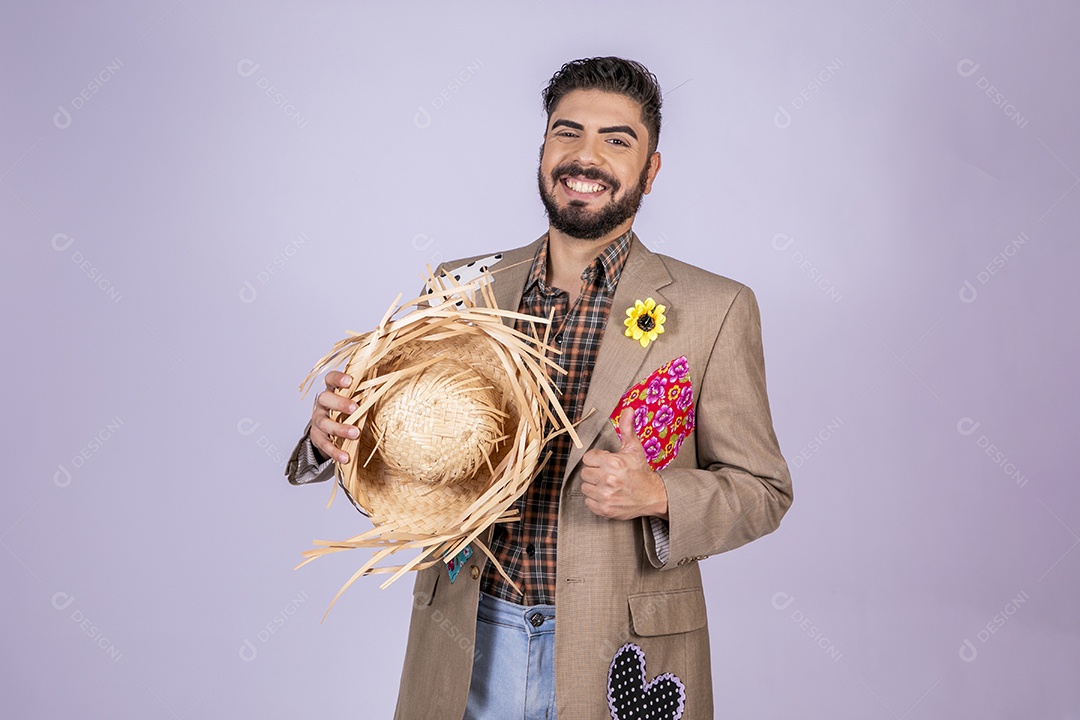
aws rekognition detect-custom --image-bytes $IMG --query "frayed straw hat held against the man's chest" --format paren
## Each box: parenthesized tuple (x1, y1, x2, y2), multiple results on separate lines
(300, 263, 580, 612)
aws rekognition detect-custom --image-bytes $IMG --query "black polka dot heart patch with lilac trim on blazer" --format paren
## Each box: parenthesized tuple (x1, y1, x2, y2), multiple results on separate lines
(608, 642, 686, 720)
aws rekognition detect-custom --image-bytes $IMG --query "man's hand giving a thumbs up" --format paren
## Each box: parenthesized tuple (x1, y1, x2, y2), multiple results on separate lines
(581, 408, 667, 520)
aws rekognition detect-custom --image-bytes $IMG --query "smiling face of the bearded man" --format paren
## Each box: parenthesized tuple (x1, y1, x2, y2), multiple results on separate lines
(537, 90, 660, 240)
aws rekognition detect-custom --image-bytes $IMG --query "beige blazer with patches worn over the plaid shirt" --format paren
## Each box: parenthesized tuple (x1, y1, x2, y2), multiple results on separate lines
(291, 240, 792, 720)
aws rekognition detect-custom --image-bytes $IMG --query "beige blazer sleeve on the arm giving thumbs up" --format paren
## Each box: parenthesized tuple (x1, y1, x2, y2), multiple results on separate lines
(643, 287, 792, 569)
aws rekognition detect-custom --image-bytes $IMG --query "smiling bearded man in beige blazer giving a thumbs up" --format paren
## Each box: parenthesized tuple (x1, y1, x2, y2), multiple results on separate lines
(288, 57, 792, 720)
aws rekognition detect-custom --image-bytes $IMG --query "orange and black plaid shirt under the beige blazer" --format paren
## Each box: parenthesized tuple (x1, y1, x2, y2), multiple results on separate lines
(481, 231, 633, 606)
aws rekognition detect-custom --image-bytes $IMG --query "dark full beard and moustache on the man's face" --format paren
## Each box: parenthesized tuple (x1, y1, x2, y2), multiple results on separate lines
(537, 153, 649, 240)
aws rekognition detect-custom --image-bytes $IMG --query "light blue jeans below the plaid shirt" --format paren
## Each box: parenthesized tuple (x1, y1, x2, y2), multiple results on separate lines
(464, 593, 555, 720)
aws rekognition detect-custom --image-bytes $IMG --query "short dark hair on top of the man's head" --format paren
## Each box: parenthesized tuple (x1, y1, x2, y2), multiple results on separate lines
(543, 57, 663, 154)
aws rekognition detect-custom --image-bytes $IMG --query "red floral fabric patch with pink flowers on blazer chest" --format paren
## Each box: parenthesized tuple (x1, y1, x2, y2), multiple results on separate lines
(610, 355, 694, 470)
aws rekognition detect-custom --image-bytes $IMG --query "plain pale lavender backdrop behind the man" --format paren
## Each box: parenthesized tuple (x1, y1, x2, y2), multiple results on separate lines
(0, 0, 1080, 720)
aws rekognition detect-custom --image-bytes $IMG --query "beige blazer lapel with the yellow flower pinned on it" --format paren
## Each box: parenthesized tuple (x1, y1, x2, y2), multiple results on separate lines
(561, 236, 672, 483)
